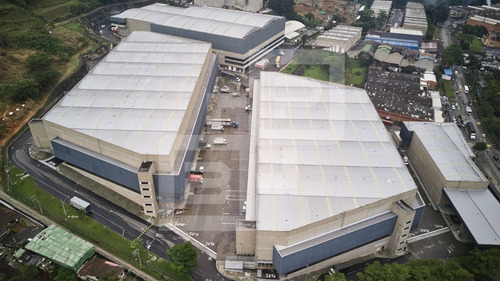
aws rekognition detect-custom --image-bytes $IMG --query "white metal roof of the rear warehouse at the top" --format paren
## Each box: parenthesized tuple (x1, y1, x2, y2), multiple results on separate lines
(113, 3, 281, 38)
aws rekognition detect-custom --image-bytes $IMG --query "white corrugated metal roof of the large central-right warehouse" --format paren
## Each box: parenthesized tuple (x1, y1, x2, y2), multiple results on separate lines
(249, 72, 416, 231)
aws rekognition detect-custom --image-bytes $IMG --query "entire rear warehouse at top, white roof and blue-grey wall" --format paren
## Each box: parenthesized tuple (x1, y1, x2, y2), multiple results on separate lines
(110, 4, 285, 72)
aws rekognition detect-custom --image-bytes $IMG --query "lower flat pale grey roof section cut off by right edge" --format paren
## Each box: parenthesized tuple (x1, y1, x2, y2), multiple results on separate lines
(444, 188, 500, 246)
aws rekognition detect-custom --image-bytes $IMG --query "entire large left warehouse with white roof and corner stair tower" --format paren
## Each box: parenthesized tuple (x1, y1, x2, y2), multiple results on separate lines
(30, 32, 217, 216)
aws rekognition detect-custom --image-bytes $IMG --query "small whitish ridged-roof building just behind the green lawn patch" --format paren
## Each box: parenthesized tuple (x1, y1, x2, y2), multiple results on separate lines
(316, 25, 362, 53)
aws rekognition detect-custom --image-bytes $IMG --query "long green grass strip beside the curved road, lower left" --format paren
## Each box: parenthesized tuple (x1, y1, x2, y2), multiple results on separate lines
(9, 164, 192, 281)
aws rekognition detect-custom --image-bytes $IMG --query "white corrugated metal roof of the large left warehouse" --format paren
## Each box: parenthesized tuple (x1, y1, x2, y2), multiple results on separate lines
(44, 32, 211, 155)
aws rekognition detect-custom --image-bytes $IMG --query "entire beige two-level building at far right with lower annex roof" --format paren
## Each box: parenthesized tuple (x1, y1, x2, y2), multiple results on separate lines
(400, 122, 500, 247)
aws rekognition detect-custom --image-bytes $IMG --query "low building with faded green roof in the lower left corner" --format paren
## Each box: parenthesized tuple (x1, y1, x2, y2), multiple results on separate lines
(25, 225, 95, 271)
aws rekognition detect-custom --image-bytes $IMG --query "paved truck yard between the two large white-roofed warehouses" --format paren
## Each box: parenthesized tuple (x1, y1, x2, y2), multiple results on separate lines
(171, 75, 251, 259)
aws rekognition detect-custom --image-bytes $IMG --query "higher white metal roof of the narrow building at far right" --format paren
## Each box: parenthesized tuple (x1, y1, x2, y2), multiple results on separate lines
(405, 122, 487, 182)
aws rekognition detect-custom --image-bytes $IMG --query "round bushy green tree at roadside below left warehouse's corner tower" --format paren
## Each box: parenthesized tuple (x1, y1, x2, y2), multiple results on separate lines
(167, 241, 198, 273)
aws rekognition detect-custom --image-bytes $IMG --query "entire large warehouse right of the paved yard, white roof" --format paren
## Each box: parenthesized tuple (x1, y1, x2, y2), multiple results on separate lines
(236, 72, 424, 277)
